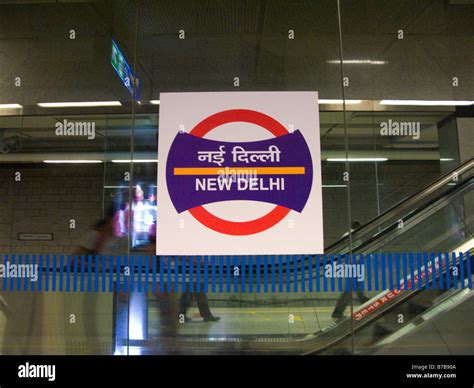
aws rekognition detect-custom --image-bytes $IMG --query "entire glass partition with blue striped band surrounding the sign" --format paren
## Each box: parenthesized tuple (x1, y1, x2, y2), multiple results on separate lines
(0, 0, 474, 355)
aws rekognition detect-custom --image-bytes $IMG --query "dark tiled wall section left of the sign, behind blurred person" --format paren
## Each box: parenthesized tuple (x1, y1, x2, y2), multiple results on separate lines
(0, 164, 103, 254)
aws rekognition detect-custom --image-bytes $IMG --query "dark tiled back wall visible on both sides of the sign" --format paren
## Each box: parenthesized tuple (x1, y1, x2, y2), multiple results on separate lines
(0, 161, 440, 254)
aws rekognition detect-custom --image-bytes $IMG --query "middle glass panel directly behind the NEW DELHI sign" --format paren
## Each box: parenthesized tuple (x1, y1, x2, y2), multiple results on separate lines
(134, 1, 347, 353)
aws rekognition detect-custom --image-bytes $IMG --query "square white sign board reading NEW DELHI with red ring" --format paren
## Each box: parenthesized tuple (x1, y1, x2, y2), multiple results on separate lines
(156, 92, 324, 255)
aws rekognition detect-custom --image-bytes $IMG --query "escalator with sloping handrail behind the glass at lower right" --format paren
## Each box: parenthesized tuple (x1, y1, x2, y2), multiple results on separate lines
(171, 159, 474, 354)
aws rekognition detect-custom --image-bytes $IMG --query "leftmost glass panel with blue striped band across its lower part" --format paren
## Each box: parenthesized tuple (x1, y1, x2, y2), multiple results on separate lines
(0, 1, 135, 354)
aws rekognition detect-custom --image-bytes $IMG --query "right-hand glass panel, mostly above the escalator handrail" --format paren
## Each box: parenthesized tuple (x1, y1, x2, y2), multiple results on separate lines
(341, 0, 474, 352)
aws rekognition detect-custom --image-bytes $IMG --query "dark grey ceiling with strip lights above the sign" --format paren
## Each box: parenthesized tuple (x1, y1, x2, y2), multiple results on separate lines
(0, 0, 474, 160)
